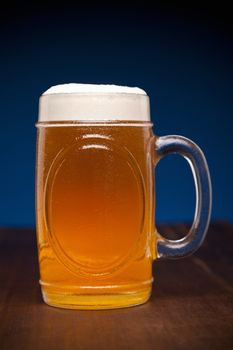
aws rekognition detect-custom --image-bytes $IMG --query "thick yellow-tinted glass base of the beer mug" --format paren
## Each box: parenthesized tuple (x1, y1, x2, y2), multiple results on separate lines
(42, 287, 151, 310)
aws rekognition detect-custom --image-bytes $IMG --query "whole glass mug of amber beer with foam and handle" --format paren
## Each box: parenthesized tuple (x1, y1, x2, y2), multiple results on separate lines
(36, 84, 211, 309)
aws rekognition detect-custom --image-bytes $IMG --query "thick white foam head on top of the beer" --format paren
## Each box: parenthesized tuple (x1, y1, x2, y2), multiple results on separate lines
(39, 84, 150, 122)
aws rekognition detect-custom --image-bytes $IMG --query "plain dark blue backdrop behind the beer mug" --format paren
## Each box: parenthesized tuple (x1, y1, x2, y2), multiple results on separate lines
(0, 2, 233, 226)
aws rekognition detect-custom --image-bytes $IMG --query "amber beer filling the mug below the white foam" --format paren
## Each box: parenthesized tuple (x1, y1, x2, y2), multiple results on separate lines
(37, 122, 155, 308)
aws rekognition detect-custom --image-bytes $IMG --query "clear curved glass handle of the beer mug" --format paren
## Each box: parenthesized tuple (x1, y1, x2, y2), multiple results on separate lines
(155, 135, 212, 259)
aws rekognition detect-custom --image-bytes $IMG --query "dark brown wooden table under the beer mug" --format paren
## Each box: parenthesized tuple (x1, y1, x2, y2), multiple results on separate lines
(0, 222, 233, 350)
